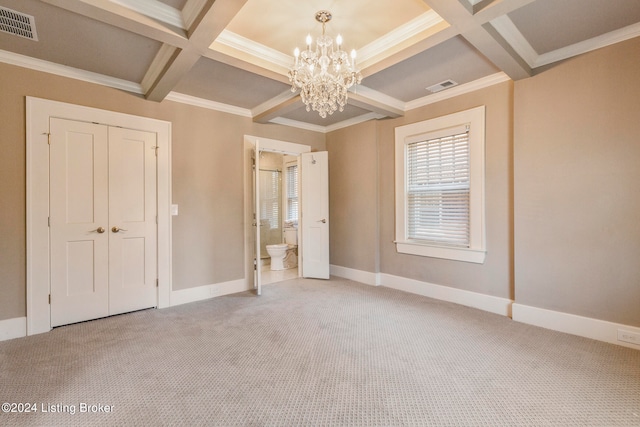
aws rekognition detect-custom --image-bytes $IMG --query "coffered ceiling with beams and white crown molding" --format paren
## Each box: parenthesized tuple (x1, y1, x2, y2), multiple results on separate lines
(0, 0, 640, 131)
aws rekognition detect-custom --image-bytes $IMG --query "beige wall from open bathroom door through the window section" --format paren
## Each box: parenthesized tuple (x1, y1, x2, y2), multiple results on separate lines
(327, 82, 513, 298)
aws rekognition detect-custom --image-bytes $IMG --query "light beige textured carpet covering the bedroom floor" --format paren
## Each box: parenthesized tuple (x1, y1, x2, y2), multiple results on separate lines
(0, 279, 640, 426)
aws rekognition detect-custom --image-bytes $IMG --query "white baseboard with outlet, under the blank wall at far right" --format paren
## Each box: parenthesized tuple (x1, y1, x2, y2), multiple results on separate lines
(513, 304, 640, 350)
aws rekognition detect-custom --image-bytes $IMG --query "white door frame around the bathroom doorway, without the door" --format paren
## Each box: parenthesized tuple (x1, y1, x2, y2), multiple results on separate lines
(243, 135, 311, 289)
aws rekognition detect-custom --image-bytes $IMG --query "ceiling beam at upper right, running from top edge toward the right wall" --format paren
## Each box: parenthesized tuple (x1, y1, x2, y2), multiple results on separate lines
(423, 0, 533, 80)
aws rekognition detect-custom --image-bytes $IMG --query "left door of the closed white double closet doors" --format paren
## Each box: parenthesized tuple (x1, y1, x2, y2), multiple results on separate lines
(50, 118, 109, 327)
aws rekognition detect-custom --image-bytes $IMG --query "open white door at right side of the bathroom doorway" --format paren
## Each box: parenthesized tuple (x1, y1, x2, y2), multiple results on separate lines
(299, 151, 329, 279)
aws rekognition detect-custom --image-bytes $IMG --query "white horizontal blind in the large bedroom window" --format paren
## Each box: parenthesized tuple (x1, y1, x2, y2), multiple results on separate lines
(406, 131, 470, 248)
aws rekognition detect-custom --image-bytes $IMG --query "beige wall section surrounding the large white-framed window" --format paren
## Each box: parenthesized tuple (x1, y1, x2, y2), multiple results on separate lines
(379, 82, 513, 298)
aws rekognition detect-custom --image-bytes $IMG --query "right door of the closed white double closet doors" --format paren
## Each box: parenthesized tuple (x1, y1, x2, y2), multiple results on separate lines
(108, 127, 158, 314)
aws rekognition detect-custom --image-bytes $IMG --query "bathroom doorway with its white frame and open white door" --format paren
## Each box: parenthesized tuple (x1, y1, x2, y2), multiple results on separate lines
(244, 135, 329, 295)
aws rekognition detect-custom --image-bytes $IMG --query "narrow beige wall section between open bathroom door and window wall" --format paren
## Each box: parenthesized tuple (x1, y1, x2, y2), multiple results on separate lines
(327, 121, 378, 272)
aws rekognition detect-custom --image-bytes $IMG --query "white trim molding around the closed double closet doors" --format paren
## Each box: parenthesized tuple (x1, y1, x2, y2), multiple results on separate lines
(26, 97, 171, 335)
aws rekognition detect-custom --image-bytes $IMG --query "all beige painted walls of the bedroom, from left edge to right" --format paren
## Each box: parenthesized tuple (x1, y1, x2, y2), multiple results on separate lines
(0, 38, 640, 332)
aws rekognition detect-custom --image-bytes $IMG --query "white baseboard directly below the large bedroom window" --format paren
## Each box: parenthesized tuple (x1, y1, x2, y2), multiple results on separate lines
(380, 273, 513, 317)
